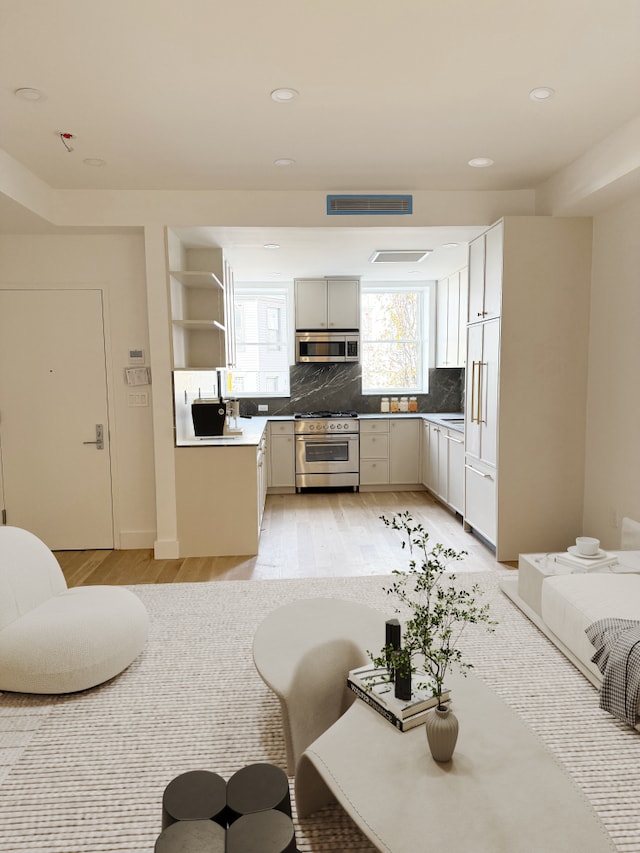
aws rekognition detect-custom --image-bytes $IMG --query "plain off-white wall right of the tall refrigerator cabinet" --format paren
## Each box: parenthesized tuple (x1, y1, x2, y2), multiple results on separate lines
(584, 194, 640, 548)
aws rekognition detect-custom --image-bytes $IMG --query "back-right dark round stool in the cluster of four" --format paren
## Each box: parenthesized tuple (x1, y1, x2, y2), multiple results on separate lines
(227, 764, 291, 823)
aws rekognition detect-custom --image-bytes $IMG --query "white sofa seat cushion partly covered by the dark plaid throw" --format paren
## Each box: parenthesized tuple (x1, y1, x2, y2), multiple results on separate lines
(541, 572, 640, 680)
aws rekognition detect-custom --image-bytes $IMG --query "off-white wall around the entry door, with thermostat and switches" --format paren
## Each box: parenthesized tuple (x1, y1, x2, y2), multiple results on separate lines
(0, 231, 156, 548)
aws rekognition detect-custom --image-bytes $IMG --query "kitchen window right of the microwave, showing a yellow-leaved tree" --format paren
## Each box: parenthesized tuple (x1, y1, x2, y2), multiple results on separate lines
(360, 282, 435, 394)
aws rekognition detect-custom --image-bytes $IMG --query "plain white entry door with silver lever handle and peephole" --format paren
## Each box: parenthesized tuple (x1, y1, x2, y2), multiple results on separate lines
(0, 290, 113, 550)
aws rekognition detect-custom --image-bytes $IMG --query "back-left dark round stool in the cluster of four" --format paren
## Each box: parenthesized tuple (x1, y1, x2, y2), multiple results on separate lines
(162, 770, 227, 829)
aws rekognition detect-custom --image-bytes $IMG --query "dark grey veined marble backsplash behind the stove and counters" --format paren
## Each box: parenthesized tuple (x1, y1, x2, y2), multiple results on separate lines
(240, 364, 464, 415)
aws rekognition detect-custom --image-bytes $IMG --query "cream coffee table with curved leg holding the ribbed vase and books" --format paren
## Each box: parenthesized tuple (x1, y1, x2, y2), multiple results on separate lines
(295, 675, 615, 853)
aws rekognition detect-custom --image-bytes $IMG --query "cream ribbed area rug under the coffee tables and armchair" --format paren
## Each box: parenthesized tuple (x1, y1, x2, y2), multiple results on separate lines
(0, 572, 640, 853)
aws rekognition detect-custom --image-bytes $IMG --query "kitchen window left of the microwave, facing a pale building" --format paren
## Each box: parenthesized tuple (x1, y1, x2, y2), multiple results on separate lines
(233, 283, 290, 397)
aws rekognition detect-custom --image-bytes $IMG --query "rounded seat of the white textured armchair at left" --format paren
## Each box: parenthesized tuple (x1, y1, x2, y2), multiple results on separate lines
(0, 586, 149, 693)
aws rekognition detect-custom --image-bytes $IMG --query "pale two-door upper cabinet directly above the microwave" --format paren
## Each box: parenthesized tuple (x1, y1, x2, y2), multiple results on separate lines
(295, 278, 360, 331)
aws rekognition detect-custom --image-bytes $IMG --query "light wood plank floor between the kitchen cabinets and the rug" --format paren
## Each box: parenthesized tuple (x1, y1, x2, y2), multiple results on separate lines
(56, 492, 516, 586)
